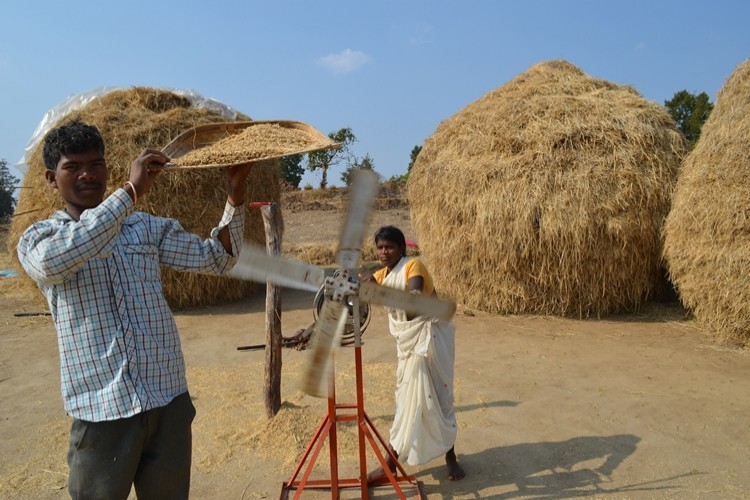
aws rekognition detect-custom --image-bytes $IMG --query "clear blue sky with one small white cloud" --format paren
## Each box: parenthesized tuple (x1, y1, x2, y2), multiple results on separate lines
(0, 0, 750, 186)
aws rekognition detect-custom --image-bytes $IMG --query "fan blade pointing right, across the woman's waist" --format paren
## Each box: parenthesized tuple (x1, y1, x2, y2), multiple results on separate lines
(359, 281, 456, 321)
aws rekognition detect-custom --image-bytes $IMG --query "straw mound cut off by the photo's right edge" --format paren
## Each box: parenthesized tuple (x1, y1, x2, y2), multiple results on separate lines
(664, 59, 750, 346)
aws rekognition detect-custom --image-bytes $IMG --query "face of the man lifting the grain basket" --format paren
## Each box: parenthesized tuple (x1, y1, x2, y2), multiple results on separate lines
(46, 149, 108, 219)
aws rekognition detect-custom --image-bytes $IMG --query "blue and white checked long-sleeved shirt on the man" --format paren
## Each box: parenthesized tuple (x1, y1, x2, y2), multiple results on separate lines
(18, 189, 245, 422)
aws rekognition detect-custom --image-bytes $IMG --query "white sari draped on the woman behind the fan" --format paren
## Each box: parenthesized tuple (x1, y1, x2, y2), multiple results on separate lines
(382, 257, 456, 465)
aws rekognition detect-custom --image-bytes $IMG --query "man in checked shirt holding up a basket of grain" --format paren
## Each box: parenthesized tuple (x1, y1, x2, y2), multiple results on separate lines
(18, 120, 250, 499)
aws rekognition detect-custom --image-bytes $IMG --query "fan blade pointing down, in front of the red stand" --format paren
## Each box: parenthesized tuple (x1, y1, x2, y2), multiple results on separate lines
(302, 299, 349, 398)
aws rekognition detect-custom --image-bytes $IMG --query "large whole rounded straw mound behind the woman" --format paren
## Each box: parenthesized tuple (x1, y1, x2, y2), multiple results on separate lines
(409, 61, 685, 317)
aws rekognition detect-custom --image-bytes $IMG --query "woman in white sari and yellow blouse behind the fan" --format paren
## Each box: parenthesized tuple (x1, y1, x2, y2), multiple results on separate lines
(360, 226, 465, 483)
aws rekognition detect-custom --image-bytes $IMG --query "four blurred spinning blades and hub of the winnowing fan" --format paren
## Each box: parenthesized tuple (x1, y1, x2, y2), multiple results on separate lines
(229, 170, 456, 397)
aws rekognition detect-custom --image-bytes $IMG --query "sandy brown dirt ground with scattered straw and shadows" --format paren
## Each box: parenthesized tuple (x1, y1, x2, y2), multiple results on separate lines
(0, 197, 750, 499)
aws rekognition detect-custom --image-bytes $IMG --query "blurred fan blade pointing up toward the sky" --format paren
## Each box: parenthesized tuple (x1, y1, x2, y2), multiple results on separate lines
(336, 170, 378, 269)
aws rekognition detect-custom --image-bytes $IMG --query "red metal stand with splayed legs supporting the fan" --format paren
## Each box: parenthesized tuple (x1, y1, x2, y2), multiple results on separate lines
(280, 301, 422, 500)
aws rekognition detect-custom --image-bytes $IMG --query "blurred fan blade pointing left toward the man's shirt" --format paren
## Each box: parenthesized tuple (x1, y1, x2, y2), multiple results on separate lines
(227, 242, 325, 292)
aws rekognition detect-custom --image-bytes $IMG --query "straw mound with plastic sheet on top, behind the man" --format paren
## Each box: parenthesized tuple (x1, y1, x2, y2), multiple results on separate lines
(8, 87, 280, 308)
